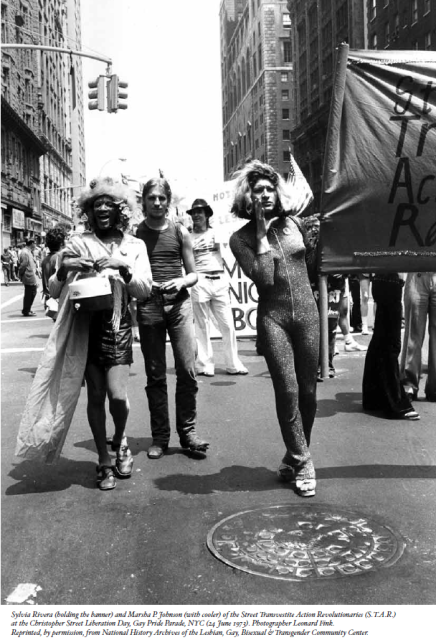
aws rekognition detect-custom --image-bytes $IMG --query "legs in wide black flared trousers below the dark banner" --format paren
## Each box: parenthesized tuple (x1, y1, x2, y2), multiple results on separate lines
(362, 273, 419, 420)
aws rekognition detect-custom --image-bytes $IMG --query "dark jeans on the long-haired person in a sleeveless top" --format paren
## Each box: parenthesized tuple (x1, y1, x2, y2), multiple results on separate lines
(138, 294, 198, 445)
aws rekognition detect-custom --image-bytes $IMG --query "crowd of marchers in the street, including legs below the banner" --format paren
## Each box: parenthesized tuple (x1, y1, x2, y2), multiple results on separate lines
(11, 160, 436, 497)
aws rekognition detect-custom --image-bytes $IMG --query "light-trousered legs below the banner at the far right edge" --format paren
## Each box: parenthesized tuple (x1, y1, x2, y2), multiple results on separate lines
(401, 272, 436, 402)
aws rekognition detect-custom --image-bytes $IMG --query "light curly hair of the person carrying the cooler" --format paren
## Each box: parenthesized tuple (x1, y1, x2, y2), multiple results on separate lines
(77, 177, 138, 231)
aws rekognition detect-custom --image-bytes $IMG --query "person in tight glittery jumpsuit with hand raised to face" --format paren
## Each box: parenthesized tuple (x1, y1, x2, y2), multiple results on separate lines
(230, 160, 319, 497)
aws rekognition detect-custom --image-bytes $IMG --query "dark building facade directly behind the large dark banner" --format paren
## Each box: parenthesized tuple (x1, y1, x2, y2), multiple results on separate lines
(287, 0, 436, 211)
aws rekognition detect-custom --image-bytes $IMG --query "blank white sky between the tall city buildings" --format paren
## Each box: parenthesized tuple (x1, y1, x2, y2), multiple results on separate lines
(81, 0, 223, 196)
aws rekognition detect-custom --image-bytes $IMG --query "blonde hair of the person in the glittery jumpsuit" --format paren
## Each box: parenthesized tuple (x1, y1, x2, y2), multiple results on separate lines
(232, 160, 293, 219)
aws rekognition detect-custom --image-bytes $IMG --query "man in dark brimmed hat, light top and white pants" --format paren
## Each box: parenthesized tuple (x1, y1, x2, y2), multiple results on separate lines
(187, 198, 248, 376)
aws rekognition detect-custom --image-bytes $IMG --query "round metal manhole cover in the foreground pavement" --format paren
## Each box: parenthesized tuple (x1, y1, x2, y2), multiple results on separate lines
(207, 505, 404, 580)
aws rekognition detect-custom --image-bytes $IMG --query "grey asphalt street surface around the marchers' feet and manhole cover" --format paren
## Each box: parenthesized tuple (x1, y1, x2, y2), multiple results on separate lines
(1, 285, 436, 606)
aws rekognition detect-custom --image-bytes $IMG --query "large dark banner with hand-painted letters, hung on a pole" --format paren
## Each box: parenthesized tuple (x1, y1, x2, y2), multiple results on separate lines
(320, 45, 436, 273)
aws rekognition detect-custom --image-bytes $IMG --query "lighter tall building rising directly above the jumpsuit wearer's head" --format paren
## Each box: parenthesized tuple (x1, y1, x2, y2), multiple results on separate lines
(220, 0, 294, 179)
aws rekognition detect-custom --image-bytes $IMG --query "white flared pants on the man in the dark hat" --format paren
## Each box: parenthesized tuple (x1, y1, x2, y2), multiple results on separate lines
(191, 273, 245, 374)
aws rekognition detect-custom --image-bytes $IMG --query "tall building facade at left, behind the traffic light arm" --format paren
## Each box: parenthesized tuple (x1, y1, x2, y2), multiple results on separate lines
(1, 0, 85, 248)
